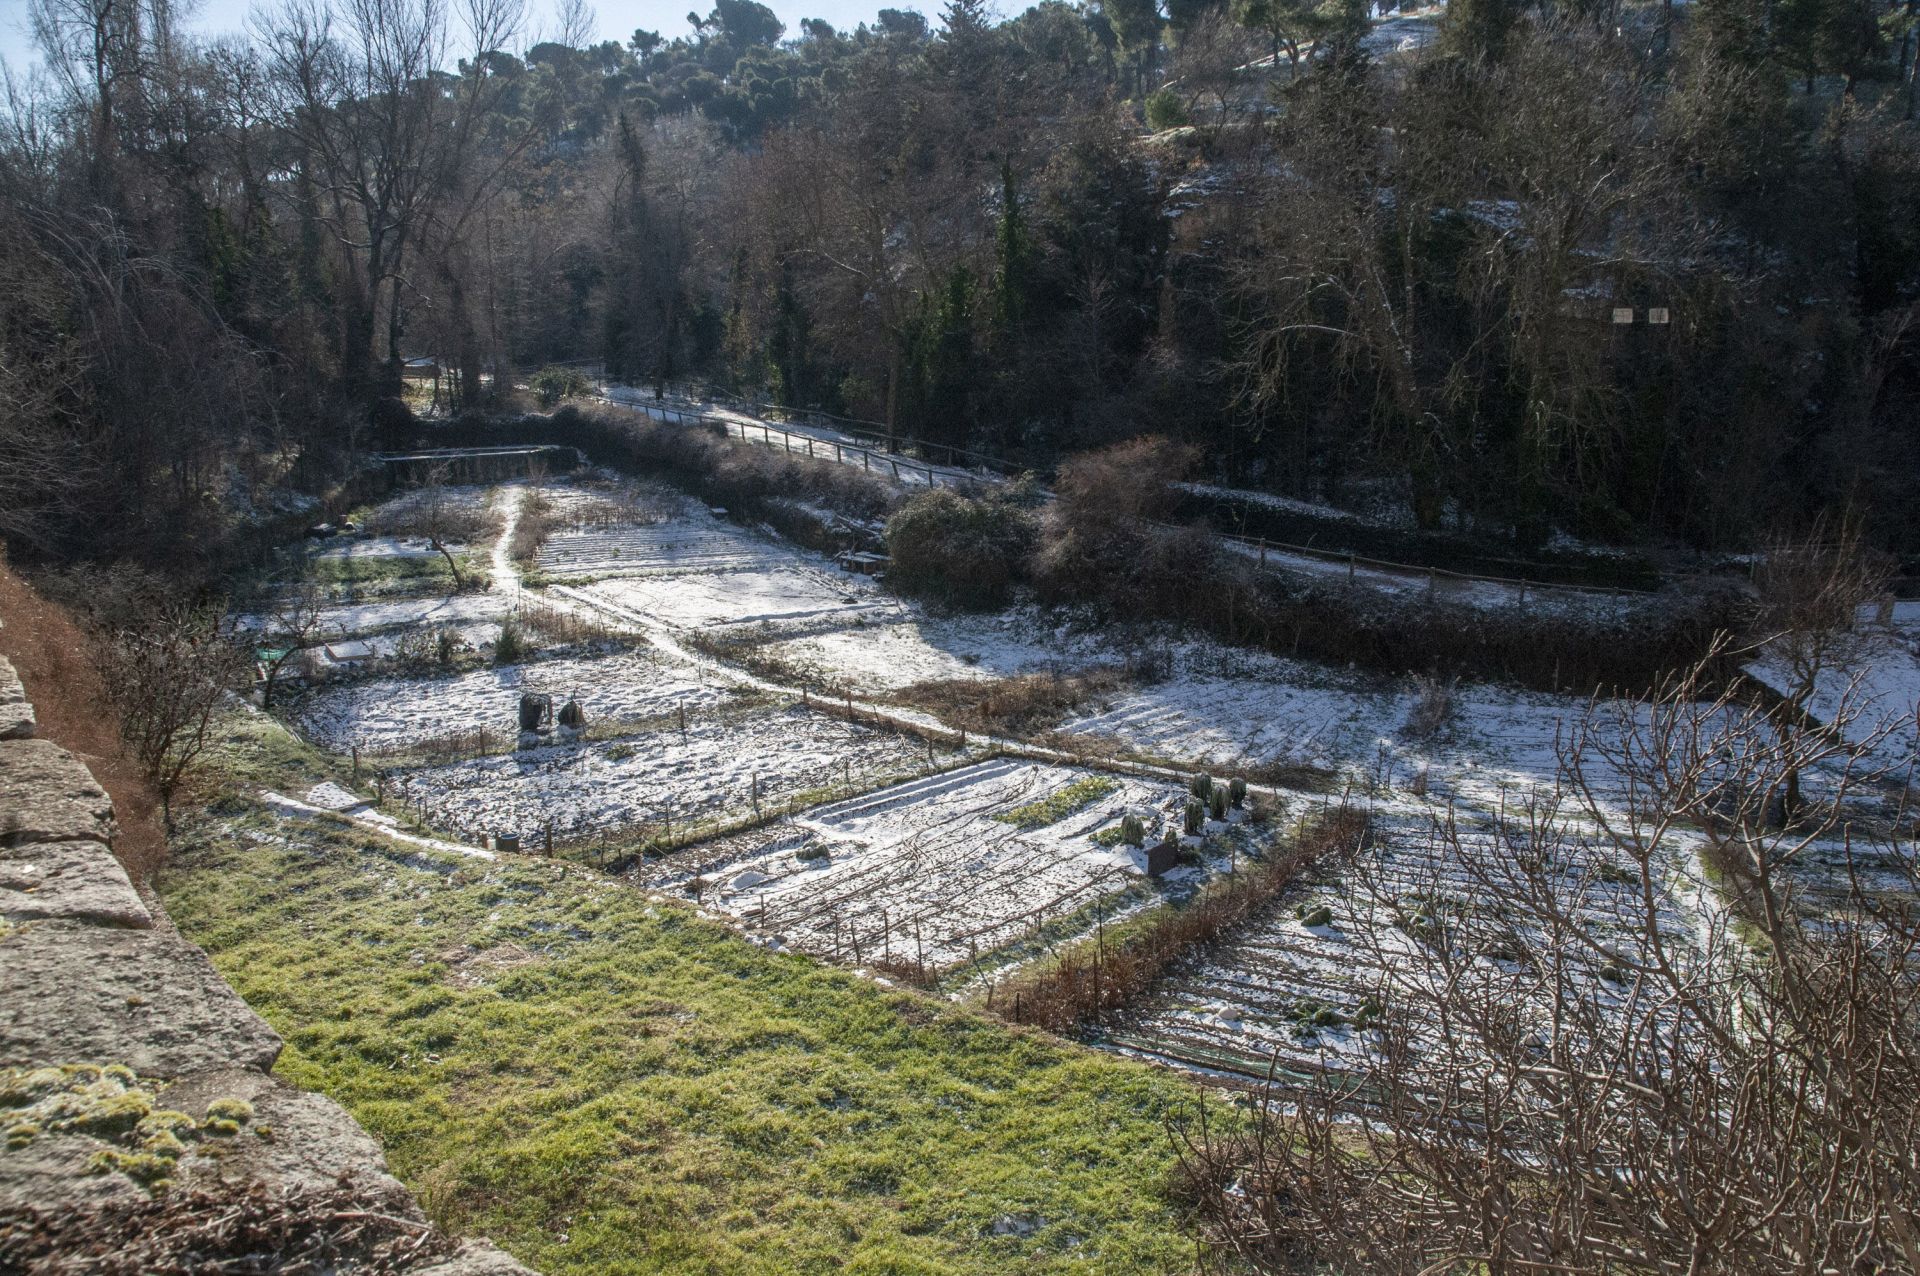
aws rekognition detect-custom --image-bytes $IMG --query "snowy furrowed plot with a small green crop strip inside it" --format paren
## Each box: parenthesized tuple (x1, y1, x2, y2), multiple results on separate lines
(683, 760, 1251, 969)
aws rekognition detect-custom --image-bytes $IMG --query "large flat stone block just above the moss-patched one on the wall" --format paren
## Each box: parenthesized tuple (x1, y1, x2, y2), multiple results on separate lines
(0, 921, 280, 1076)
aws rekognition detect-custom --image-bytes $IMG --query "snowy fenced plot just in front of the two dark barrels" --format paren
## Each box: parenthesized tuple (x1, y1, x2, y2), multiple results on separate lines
(386, 708, 925, 851)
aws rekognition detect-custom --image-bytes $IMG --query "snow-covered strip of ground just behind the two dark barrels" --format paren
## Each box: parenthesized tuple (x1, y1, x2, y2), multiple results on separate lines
(292, 650, 728, 752)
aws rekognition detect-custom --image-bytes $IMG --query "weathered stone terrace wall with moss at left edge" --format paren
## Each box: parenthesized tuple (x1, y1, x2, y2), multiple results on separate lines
(0, 656, 528, 1276)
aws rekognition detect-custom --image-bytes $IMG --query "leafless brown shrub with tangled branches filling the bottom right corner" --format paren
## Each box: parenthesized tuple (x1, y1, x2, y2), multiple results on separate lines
(1181, 648, 1920, 1276)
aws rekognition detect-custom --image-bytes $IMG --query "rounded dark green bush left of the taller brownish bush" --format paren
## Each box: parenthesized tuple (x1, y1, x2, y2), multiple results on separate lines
(887, 487, 1035, 610)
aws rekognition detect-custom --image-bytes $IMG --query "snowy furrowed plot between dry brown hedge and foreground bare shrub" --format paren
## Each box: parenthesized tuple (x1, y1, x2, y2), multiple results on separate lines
(1114, 804, 1705, 1078)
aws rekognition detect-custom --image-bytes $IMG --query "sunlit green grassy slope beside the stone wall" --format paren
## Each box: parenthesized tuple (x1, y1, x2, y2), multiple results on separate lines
(163, 718, 1194, 1276)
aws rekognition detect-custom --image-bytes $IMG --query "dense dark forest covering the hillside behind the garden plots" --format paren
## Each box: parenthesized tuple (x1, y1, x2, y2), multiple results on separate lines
(0, 0, 1920, 558)
